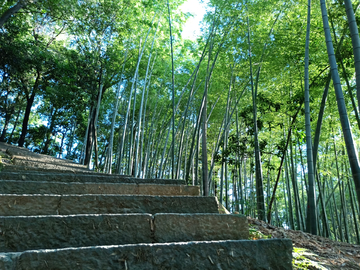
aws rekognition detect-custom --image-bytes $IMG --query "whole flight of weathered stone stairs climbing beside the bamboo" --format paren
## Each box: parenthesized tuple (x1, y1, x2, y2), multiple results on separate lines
(0, 143, 292, 270)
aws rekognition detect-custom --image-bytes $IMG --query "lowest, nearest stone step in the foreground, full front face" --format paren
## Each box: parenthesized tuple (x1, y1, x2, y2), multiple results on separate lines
(0, 239, 292, 270)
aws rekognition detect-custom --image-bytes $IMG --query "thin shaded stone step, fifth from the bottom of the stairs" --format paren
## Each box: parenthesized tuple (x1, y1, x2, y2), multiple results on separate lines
(0, 170, 185, 185)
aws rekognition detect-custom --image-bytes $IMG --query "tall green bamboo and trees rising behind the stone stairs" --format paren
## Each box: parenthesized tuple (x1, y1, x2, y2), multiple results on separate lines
(0, 0, 360, 244)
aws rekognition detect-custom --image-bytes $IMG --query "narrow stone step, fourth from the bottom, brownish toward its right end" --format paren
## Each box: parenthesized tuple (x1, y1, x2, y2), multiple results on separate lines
(0, 180, 200, 196)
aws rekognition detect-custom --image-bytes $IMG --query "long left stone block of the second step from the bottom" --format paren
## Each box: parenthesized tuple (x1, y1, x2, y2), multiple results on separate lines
(0, 214, 153, 252)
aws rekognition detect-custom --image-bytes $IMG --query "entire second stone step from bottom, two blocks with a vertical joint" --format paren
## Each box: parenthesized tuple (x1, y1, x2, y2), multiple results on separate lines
(0, 214, 249, 252)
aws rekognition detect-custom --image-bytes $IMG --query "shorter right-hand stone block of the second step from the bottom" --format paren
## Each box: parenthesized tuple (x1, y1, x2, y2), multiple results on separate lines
(154, 214, 249, 243)
